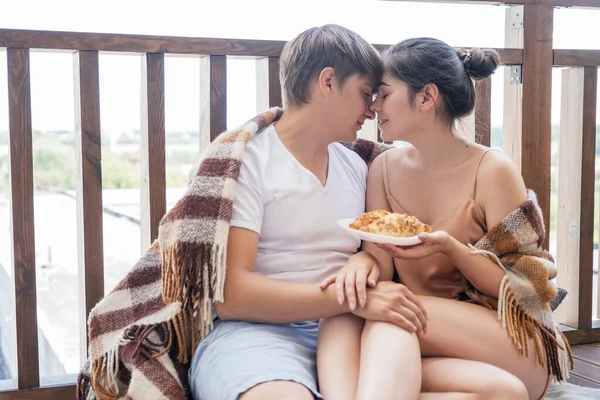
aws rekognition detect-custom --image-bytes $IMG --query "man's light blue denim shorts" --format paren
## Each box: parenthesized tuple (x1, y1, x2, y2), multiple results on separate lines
(189, 319, 322, 400)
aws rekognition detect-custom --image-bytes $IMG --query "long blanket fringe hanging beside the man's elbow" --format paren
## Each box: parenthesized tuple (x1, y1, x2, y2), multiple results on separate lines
(161, 242, 226, 340)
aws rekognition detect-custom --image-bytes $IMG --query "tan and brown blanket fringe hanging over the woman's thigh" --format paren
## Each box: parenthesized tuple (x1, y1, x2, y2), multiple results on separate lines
(498, 276, 574, 382)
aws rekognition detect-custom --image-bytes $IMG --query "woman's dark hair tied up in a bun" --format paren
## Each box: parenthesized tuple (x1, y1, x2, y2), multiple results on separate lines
(383, 38, 500, 122)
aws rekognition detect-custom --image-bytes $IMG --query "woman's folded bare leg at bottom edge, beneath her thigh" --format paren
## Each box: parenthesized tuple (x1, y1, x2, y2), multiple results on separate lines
(419, 358, 529, 400)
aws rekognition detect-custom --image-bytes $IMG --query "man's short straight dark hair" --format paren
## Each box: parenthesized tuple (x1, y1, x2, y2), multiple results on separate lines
(279, 24, 383, 107)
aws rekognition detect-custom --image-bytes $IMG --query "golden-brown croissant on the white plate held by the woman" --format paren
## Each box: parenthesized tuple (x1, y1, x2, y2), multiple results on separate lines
(348, 210, 431, 237)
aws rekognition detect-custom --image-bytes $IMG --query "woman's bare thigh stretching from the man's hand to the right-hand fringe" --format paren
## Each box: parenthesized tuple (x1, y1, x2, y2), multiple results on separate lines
(419, 296, 549, 399)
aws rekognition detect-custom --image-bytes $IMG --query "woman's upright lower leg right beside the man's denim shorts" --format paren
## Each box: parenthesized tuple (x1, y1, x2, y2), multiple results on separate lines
(317, 314, 365, 400)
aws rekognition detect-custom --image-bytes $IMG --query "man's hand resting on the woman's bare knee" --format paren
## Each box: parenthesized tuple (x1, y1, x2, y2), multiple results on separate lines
(353, 281, 427, 337)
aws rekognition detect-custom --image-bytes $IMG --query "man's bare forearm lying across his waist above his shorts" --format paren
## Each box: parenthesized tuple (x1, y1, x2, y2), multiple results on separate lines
(215, 270, 349, 323)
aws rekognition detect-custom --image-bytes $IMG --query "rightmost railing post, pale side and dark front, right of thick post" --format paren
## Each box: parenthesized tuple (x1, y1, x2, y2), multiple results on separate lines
(556, 67, 597, 328)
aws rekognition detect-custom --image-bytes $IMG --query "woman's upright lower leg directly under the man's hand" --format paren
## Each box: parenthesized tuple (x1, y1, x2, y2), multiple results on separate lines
(356, 321, 421, 400)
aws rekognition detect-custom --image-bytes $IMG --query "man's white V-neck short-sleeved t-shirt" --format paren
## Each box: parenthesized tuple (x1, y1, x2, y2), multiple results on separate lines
(231, 125, 367, 282)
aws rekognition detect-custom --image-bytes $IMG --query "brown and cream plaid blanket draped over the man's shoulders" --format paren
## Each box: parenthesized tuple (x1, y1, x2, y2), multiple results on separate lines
(77, 108, 389, 400)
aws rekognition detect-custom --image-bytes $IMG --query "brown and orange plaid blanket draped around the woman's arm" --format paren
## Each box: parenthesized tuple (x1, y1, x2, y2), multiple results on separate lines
(465, 190, 573, 381)
